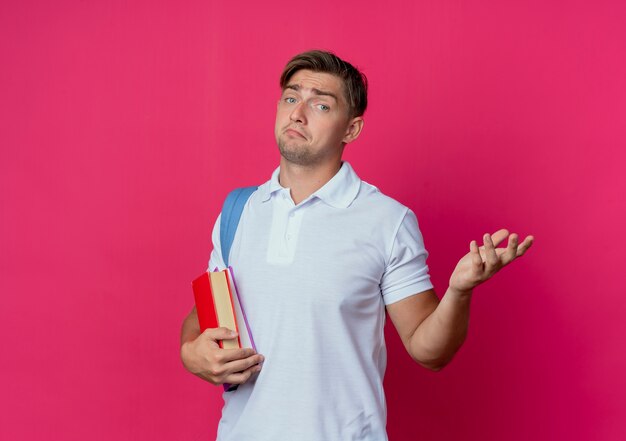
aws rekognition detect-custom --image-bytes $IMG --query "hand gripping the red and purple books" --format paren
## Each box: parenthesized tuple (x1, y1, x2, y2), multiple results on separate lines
(180, 328, 263, 384)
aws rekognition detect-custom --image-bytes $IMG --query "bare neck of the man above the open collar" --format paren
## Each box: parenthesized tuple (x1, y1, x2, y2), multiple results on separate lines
(278, 158, 341, 205)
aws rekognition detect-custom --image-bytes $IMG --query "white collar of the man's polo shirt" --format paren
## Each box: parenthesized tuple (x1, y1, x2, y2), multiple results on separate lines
(260, 161, 361, 208)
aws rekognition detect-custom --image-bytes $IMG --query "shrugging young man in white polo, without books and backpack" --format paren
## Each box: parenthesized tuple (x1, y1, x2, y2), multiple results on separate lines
(181, 51, 533, 441)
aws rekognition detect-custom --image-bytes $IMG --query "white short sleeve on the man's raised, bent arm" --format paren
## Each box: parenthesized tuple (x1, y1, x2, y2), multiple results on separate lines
(380, 209, 433, 305)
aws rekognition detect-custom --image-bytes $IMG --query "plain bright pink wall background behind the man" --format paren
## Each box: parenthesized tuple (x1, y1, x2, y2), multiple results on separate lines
(0, 0, 626, 441)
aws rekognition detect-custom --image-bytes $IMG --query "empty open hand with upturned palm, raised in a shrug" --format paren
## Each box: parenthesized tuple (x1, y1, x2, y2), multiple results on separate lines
(450, 230, 534, 294)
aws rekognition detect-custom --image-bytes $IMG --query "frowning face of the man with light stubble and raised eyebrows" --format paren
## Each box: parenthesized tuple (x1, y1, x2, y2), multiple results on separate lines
(275, 70, 362, 166)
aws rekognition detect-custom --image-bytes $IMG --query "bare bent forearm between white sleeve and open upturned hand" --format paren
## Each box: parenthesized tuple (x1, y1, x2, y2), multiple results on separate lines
(408, 288, 472, 370)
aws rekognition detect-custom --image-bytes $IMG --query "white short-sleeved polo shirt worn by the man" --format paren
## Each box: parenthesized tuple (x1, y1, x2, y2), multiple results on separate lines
(209, 162, 432, 441)
